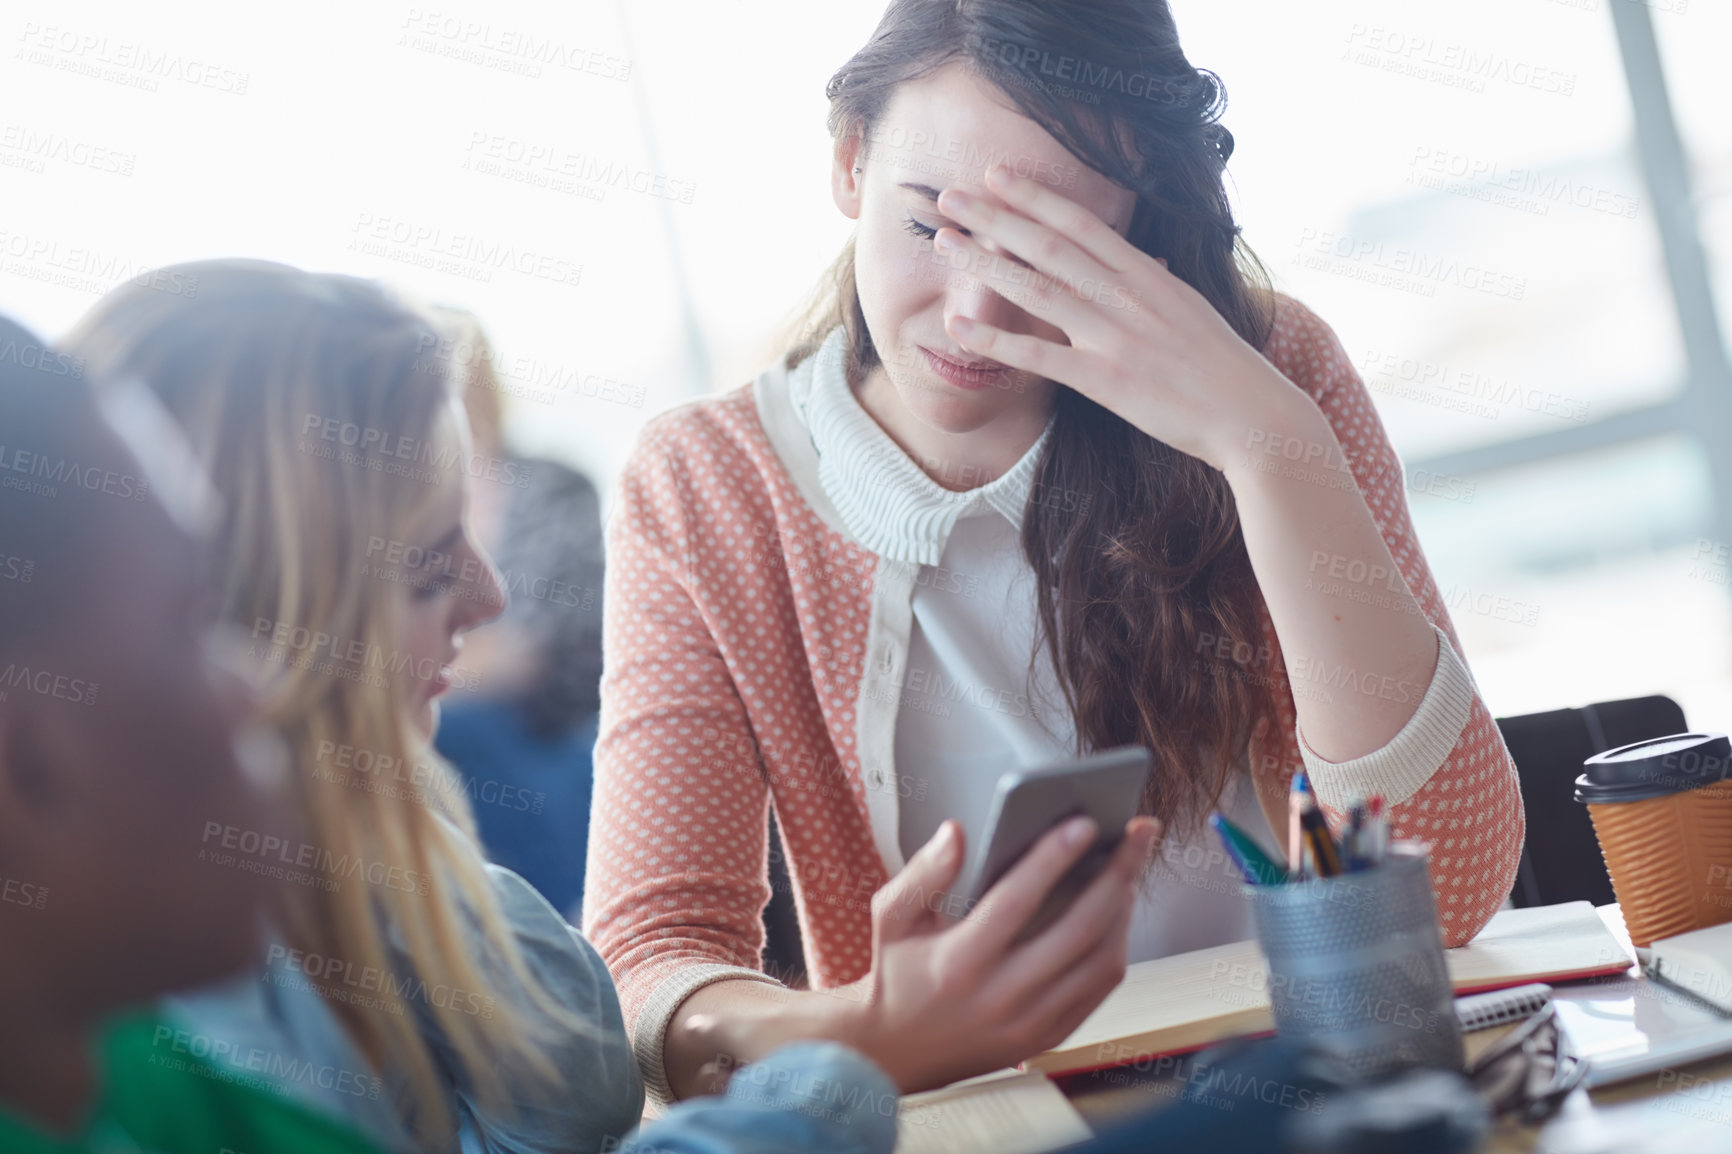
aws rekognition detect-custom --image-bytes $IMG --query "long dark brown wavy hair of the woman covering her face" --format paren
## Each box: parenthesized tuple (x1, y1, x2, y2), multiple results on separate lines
(788, 0, 1275, 828)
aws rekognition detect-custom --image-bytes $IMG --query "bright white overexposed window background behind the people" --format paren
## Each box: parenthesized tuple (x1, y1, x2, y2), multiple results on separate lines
(0, 0, 1732, 728)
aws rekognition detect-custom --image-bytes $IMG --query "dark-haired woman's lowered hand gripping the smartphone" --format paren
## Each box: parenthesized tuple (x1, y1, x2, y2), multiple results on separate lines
(845, 816, 1160, 1093)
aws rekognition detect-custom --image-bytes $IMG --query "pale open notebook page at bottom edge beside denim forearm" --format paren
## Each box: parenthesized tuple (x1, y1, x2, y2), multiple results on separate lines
(895, 1071, 1095, 1154)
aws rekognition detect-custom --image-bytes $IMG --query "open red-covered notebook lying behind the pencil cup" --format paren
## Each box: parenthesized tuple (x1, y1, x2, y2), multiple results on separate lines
(1024, 901, 1630, 1076)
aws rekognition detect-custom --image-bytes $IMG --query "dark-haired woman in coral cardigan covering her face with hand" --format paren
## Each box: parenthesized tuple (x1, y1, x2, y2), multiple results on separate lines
(584, 0, 1524, 1095)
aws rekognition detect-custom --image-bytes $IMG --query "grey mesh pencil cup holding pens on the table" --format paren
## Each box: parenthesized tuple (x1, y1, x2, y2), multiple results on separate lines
(1249, 844, 1464, 1078)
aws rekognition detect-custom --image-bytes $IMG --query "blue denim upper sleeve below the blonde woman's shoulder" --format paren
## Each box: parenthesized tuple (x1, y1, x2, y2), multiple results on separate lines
(457, 866, 644, 1154)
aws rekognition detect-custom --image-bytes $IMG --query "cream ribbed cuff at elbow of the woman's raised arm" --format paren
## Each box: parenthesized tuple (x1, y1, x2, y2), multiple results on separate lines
(1299, 626, 1476, 809)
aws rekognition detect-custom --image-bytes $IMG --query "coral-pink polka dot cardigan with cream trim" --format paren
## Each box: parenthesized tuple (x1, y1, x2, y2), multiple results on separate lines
(584, 296, 1524, 1099)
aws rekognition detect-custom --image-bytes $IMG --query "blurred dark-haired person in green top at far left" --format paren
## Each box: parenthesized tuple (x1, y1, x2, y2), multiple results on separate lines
(0, 319, 374, 1154)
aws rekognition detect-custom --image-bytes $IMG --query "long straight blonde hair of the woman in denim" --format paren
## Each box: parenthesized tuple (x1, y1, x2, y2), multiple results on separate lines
(66, 260, 591, 1145)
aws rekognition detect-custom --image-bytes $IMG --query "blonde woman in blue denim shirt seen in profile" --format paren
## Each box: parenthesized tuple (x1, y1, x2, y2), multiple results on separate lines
(68, 262, 895, 1151)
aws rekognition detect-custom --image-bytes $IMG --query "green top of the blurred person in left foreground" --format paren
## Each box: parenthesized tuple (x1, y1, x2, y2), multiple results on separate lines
(0, 1014, 378, 1154)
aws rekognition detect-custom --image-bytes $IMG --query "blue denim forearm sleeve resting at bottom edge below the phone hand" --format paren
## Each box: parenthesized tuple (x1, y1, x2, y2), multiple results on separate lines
(620, 1041, 899, 1154)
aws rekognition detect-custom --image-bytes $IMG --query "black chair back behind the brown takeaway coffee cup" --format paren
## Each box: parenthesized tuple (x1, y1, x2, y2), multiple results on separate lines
(1498, 697, 1687, 906)
